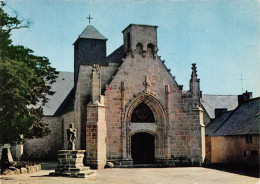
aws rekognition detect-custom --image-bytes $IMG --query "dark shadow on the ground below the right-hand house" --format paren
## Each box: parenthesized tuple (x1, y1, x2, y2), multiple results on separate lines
(207, 164, 260, 178)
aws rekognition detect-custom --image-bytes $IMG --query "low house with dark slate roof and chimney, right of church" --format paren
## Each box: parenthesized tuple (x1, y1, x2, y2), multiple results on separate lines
(206, 92, 260, 166)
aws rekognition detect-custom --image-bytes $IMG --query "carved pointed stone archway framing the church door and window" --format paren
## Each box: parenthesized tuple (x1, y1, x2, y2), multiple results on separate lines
(122, 93, 169, 159)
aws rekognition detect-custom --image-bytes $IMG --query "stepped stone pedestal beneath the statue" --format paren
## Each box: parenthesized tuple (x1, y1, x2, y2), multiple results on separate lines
(49, 150, 94, 178)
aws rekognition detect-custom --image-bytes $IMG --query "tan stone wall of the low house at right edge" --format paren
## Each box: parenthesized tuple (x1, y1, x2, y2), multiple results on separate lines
(211, 135, 260, 165)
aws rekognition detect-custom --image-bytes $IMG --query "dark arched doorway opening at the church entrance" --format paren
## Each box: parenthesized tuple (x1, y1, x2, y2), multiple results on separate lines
(131, 133, 154, 164)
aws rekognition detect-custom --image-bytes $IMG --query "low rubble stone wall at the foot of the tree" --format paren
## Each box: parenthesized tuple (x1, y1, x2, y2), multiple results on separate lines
(3, 164, 41, 175)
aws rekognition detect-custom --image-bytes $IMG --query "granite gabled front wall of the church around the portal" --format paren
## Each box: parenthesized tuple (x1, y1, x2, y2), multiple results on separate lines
(105, 52, 202, 162)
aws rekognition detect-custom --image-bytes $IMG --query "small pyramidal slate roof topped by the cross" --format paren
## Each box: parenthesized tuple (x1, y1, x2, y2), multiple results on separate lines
(74, 24, 107, 44)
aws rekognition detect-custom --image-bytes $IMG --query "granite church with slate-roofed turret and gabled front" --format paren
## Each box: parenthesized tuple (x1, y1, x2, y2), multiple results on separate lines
(23, 24, 205, 168)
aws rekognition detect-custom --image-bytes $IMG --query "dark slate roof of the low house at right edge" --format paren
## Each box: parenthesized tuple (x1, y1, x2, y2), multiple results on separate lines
(206, 97, 260, 136)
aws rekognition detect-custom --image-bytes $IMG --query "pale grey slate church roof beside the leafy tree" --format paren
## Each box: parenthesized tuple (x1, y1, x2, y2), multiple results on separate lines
(43, 72, 74, 116)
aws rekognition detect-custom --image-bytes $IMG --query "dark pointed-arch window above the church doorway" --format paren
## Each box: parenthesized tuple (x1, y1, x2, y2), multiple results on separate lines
(131, 103, 155, 123)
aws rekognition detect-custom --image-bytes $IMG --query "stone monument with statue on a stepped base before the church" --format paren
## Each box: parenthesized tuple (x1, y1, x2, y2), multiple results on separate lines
(49, 123, 94, 178)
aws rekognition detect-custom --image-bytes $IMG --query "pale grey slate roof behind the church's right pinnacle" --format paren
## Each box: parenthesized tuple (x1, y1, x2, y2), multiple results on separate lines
(200, 95, 238, 119)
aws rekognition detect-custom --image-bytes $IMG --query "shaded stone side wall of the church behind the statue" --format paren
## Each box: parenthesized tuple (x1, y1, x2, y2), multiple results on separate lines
(24, 117, 63, 160)
